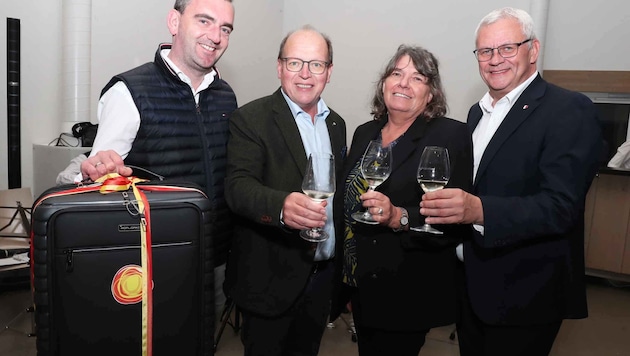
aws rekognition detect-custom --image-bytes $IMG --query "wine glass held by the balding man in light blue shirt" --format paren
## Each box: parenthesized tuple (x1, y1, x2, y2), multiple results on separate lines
(300, 152, 335, 242)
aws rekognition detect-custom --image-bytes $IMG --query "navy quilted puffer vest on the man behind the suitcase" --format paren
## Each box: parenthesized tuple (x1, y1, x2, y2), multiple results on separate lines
(101, 44, 237, 266)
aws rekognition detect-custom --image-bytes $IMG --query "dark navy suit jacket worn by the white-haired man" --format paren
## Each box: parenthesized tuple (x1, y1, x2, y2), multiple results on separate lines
(464, 75, 602, 325)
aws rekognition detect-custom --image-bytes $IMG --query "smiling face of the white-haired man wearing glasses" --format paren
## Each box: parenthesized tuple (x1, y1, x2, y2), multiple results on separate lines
(476, 18, 540, 102)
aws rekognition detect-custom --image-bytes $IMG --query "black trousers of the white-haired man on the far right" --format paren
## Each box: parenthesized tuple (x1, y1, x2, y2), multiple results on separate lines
(457, 266, 562, 356)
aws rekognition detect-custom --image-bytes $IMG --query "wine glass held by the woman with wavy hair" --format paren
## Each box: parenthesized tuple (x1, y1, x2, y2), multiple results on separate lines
(352, 140, 392, 225)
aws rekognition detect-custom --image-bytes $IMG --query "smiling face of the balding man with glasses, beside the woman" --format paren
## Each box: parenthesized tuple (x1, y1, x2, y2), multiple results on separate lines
(277, 30, 332, 118)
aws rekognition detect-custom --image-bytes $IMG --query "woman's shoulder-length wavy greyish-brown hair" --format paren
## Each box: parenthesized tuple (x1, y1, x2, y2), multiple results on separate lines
(371, 44, 448, 120)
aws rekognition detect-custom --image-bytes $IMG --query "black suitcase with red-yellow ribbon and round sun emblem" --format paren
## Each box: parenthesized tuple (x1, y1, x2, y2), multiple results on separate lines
(31, 177, 215, 356)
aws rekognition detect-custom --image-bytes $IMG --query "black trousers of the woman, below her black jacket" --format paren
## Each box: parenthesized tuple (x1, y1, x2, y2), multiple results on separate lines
(349, 287, 429, 356)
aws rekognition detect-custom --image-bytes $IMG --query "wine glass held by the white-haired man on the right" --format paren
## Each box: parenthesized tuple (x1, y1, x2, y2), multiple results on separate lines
(409, 146, 451, 235)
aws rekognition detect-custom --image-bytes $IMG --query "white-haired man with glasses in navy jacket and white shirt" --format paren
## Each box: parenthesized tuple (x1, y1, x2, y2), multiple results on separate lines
(420, 8, 602, 356)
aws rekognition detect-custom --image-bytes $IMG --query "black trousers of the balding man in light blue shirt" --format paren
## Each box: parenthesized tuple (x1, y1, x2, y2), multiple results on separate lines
(241, 262, 334, 356)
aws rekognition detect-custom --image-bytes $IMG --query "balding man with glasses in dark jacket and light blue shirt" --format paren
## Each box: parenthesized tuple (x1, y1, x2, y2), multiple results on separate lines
(224, 26, 346, 355)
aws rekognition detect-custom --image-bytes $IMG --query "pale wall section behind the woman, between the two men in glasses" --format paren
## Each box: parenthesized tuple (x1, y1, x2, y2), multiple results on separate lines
(284, 0, 529, 139)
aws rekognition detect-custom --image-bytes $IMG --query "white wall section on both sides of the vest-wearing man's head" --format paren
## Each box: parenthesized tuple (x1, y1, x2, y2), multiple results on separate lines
(91, 0, 283, 111)
